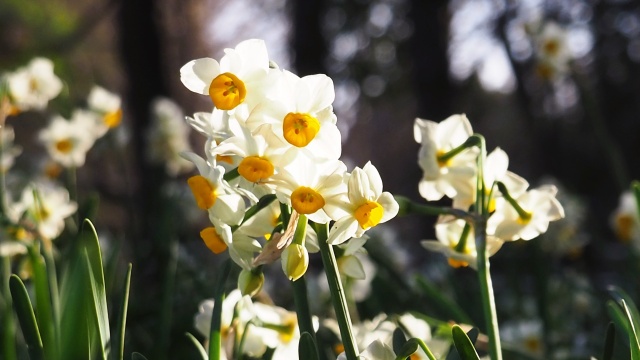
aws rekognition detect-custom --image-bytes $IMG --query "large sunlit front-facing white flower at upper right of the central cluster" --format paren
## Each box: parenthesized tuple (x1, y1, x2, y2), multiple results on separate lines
(247, 71, 342, 159)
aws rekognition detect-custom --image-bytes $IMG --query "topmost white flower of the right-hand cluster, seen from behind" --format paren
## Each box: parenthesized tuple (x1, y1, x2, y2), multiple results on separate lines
(413, 115, 479, 201)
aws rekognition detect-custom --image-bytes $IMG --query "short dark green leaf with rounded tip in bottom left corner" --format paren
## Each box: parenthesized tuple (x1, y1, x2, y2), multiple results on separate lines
(9, 275, 45, 360)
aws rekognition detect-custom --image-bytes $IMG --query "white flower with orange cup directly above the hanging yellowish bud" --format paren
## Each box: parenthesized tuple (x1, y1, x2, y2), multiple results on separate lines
(270, 158, 347, 224)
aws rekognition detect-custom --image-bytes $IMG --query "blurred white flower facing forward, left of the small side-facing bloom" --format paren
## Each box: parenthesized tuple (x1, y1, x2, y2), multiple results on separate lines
(39, 110, 96, 167)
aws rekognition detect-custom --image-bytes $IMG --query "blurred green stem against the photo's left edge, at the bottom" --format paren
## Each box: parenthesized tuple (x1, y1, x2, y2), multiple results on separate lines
(0, 256, 18, 360)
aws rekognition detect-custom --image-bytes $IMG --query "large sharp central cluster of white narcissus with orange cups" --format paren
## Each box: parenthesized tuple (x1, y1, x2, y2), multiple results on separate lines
(180, 39, 398, 280)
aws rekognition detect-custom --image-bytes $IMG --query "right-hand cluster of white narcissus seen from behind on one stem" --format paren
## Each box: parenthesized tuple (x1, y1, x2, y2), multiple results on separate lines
(414, 115, 564, 267)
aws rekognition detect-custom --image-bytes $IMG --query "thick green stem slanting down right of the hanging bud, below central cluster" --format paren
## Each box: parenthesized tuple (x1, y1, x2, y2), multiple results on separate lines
(315, 224, 359, 360)
